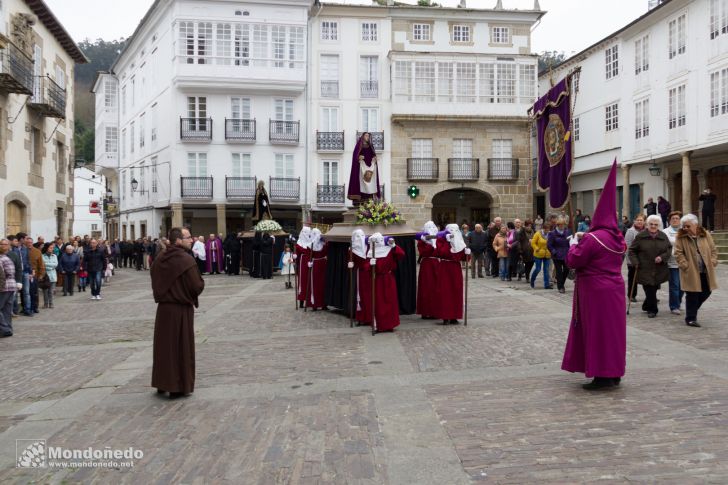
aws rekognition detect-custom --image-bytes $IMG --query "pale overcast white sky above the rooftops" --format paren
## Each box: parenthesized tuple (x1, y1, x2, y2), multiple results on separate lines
(45, 0, 647, 55)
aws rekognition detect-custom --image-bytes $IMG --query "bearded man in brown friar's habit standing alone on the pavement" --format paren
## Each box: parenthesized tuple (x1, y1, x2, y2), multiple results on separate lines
(151, 228, 205, 397)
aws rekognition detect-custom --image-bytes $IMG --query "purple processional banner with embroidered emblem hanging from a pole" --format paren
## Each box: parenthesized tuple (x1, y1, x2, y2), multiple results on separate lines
(533, 78, 573, 208)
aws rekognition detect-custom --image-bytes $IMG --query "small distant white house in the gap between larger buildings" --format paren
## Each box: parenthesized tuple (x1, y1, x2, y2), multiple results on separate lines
(72, 168, 106, 238)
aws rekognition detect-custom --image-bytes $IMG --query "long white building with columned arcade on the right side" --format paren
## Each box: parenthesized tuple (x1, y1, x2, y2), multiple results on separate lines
(540, 0, 728, 229)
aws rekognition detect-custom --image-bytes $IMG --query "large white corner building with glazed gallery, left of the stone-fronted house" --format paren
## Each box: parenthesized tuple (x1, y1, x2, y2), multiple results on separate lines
(93, 0, 312, 239)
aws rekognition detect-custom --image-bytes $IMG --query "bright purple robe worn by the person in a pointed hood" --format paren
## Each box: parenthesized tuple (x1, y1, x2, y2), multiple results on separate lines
(561, 230, 627, 377)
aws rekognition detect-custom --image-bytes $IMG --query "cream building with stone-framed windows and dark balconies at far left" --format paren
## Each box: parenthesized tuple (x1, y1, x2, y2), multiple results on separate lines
(0, 0, 87, 240)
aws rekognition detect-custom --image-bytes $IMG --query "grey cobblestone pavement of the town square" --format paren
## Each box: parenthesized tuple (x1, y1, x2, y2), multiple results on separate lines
(0, 266, 728, 484)
